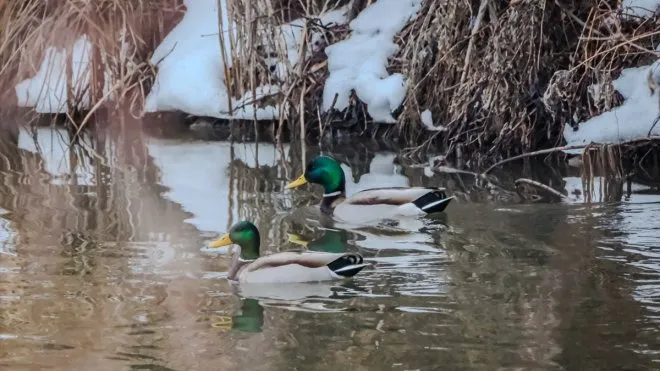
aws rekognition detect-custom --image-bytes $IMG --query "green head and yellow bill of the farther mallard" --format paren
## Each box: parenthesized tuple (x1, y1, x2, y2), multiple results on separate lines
(286, 155, 346, 194)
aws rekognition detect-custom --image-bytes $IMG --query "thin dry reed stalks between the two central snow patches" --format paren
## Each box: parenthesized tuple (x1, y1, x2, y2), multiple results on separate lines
(221, 0, 350, 140)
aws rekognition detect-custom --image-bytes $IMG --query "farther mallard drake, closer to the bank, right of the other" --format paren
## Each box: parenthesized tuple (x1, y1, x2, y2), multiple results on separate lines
(286, 156, 453, 220)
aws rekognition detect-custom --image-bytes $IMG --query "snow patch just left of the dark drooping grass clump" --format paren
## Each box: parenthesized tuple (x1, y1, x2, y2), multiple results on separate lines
(323, 0, 422, 123)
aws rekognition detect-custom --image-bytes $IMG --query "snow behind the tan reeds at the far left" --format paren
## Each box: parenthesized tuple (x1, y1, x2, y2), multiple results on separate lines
(14, 35, 113, 113)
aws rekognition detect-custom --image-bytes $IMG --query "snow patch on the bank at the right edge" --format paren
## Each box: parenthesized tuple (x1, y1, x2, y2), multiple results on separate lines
(564, 60, 660, 154)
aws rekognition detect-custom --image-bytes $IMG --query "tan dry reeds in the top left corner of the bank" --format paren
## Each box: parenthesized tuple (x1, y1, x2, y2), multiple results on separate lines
(0, 0, 185, 123)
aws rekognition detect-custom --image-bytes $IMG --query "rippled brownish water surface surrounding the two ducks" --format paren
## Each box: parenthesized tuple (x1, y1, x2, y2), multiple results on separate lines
(0, 129, 660, 370)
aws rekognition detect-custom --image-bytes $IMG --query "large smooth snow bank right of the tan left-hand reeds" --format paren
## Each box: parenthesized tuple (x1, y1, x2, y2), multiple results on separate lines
(144, 0, 346, 120)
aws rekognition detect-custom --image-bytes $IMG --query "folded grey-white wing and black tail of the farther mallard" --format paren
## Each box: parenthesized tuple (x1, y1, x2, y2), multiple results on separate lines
(342, 187, 453, 214)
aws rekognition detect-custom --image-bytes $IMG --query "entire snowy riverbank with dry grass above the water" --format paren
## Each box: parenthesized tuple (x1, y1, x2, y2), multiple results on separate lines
(0, 0, 660, 164)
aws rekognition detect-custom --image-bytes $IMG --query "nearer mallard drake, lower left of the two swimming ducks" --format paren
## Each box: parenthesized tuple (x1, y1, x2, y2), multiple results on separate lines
(210, 221, 368, 283)
